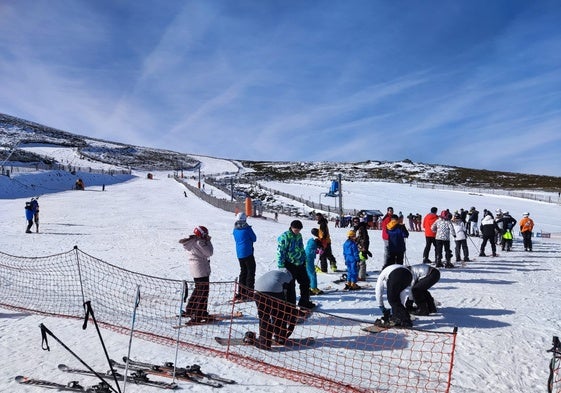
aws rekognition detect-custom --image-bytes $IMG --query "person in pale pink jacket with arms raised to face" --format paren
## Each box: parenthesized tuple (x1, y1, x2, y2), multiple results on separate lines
(179, 225, 214, 323)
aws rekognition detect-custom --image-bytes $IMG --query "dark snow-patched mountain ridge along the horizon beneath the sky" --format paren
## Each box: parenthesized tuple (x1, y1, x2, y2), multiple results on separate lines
(0, 114, 561, 191)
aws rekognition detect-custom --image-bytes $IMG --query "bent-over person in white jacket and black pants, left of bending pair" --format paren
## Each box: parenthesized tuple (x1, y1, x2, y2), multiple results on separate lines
(376, 265, 413, 327)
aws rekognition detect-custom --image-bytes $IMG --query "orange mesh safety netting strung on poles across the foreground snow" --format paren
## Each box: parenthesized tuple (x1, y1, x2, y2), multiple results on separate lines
(0, 247, 457, 393)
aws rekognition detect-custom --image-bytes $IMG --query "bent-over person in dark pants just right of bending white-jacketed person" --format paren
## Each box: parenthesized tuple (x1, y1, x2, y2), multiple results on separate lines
(405, 263, 440, 315)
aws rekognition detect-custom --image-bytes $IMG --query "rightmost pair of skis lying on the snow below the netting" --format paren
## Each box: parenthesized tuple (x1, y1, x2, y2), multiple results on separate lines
(116, 356, 237, 387)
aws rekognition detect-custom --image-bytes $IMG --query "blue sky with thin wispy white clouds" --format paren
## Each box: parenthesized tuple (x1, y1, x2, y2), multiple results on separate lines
(0, 0, 561, 176)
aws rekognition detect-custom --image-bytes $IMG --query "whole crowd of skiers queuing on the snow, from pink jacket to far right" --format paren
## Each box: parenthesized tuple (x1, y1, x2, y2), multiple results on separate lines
(179, 207, 533, 349)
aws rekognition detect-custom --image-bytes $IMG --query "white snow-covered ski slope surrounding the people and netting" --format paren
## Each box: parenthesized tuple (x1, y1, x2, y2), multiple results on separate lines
(0, 157, 561, 393)
